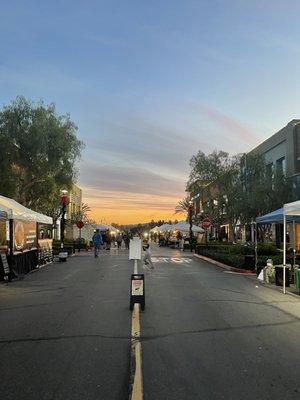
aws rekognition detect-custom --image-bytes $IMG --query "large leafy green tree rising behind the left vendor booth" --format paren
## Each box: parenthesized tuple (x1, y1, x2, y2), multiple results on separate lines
(0, 97, 83, 215)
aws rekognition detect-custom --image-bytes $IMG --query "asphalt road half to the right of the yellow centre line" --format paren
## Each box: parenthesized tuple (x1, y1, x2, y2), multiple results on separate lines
(141, 248, 300, 400)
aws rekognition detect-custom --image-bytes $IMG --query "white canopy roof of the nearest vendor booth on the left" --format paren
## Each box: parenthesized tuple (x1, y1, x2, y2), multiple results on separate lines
(0, 195, 53, 225)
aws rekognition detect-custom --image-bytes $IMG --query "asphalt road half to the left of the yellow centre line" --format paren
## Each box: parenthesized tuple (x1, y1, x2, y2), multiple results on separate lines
(0, 254, 132, 400)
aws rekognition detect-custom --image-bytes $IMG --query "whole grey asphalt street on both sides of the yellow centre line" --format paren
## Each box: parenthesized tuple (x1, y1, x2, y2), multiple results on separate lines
(0, 248, 300, 400)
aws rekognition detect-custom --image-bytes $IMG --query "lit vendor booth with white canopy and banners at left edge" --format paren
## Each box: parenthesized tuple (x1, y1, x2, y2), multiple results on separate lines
(0, 195, 53, 274)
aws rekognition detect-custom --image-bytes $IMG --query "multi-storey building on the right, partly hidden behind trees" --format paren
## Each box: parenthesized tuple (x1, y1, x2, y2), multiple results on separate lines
(194, 119, 300, 244)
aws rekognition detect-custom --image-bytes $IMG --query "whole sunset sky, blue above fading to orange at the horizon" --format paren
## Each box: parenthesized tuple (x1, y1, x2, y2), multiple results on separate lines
(0, 0, 300, 223)
